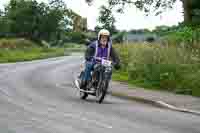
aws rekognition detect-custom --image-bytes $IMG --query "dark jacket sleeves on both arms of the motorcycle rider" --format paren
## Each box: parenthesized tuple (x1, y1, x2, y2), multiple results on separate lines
(85, 41, 120, 66)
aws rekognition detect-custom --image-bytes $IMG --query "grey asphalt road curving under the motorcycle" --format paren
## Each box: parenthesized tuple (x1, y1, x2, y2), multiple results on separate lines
(0, 56, 200, 133)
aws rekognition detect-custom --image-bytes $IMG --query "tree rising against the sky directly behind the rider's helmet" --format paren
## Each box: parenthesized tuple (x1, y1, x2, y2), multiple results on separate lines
(96, 6, 116, 33)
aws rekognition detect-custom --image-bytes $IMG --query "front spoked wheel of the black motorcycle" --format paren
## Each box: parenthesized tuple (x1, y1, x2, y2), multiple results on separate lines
(96, 81, 108, 104)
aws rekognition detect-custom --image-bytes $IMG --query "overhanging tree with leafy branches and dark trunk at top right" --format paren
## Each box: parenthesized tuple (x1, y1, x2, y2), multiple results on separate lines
(86, 0, 200, 23)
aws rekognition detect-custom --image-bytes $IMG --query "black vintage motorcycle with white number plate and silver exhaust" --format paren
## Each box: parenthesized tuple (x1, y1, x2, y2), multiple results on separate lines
(74, 57, 113, 103)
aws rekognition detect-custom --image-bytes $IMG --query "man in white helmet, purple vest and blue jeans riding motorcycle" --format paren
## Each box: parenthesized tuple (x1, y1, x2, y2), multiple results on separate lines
(80, 29, 120, 89)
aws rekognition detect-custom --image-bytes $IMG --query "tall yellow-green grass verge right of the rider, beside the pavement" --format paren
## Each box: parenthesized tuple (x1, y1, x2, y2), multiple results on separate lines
(116, 44, 200, 96)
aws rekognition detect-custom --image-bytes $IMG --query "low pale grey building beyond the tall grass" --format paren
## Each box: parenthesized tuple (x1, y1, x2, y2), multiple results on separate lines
(123, 33, 158, 44)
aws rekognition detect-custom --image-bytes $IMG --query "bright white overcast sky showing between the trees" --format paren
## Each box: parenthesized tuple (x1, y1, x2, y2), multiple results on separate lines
(0, 0, 183, 30)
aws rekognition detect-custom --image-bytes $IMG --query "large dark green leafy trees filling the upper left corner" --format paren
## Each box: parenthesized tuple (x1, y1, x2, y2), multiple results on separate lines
(0, 0, 70, 41)
